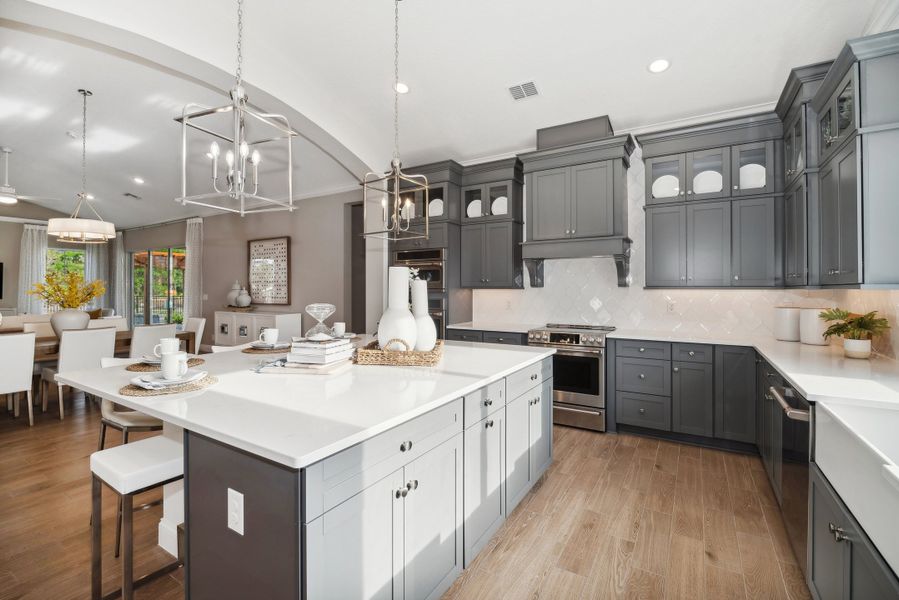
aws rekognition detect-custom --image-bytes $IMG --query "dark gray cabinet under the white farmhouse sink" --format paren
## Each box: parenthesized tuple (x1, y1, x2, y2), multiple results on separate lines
(808, 463, 899, 600)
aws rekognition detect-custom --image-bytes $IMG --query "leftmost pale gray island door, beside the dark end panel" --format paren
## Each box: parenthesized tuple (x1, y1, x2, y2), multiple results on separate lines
(305, 469, 405, 600)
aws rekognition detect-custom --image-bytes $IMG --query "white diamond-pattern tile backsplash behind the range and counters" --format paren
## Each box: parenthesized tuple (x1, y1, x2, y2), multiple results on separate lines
(473, 148, 899, 356)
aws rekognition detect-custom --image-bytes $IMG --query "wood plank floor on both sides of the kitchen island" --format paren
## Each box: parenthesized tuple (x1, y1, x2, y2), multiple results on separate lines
(0, 400, 809, 600)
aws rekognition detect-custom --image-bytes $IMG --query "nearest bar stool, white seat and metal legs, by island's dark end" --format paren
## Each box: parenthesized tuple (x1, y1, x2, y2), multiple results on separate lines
(91, 436, 184, 600)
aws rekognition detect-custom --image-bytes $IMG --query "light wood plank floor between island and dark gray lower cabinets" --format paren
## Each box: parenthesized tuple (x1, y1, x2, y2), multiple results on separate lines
(444, 427, 809, 600)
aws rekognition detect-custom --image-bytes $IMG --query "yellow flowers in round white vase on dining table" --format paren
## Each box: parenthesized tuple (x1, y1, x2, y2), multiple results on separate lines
(28, 271, 106, 338)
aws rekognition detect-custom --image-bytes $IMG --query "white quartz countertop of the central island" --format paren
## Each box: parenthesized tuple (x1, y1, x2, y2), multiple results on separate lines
(57, 342, 554, 468)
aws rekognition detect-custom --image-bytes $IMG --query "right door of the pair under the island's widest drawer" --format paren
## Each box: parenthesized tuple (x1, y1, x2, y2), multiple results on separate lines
(406, 434, 462, 600)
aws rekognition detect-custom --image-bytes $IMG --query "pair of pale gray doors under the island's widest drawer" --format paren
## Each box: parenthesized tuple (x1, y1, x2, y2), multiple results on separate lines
(306, 435, 462, 599)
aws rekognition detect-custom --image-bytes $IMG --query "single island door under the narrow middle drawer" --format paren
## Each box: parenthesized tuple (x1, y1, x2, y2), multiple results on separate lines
(464, 409, 506, 567)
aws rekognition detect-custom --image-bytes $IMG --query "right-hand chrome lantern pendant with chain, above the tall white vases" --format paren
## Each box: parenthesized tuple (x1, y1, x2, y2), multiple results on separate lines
(361, 0, 429, 241)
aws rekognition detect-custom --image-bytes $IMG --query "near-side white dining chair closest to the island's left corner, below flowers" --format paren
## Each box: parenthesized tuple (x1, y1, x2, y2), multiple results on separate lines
(41, 327, 115, 420)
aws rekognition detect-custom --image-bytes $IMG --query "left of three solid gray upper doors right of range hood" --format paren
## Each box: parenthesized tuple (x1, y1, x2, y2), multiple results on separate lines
(646, 206, 687, 287)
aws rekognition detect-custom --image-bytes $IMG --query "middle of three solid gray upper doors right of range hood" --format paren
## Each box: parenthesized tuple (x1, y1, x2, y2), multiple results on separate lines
(687, 200, 731, 287)
